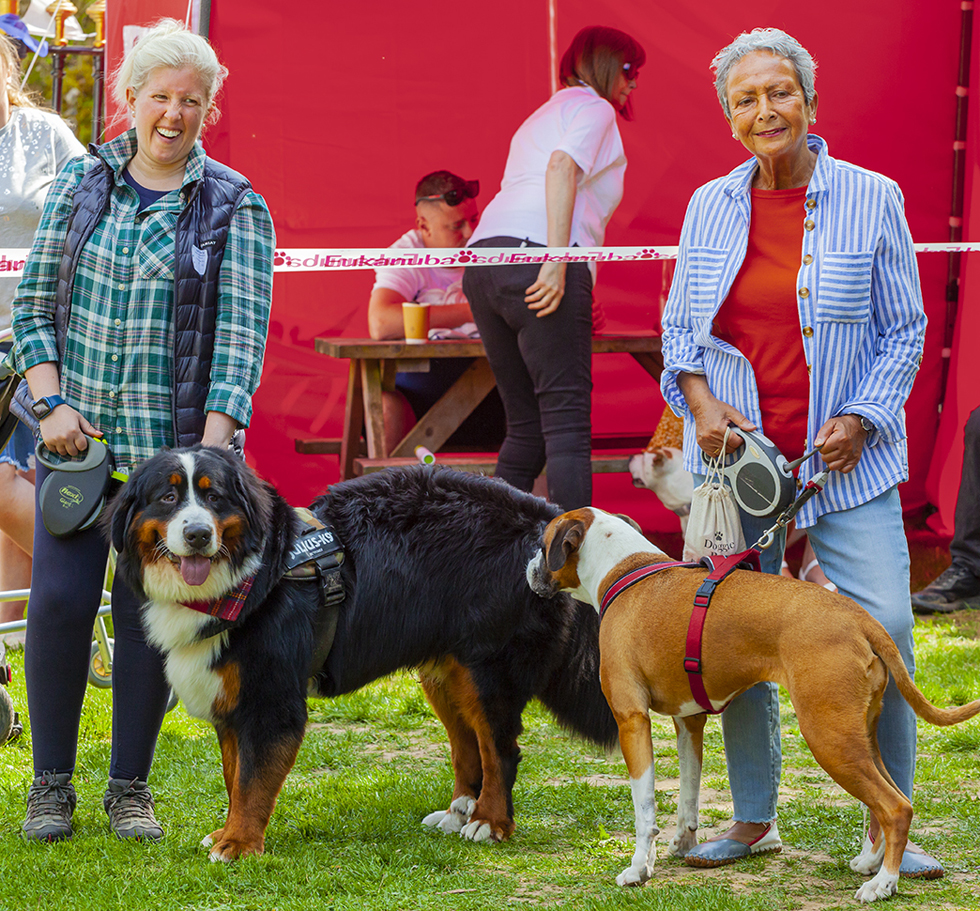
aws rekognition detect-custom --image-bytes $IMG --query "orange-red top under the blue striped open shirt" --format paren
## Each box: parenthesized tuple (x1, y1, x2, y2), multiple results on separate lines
(714, 187, 810, 459)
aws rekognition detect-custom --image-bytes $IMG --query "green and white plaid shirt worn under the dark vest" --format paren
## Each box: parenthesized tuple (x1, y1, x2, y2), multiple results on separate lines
(11, 130, 275, 466)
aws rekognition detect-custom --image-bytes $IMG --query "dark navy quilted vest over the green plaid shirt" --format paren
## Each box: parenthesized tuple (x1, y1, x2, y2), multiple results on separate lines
(55, 146, 251, 446)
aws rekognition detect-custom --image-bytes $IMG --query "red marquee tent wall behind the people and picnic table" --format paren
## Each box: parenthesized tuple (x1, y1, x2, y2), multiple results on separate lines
(108, 0, 980, 532)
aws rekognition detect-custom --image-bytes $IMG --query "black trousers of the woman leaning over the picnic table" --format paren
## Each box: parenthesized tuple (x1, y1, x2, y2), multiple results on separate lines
(463, 237, 592, 510)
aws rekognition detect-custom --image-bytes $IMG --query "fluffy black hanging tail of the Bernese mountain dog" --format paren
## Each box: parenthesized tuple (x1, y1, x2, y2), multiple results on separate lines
(535, 598, 619, 747)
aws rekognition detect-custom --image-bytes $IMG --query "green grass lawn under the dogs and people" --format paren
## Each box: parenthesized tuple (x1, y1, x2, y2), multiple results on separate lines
(0, 613, 980, 911)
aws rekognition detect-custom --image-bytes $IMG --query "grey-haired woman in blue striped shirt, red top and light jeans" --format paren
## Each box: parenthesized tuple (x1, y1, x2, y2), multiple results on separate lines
(661, 29, 943, 897)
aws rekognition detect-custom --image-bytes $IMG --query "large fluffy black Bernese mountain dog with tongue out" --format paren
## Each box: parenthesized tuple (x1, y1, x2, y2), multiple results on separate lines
(106, 446, 617, 861)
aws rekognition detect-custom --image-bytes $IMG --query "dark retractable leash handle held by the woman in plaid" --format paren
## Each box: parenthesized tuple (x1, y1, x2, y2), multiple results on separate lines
(35, 437, 125, 538)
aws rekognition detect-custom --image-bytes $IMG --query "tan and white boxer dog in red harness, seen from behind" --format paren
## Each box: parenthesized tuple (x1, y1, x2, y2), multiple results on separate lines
(527, 508, 980, 902)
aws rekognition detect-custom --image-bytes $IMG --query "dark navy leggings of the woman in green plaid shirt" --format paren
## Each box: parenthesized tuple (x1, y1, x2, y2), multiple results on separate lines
(24, 465, 169, 781)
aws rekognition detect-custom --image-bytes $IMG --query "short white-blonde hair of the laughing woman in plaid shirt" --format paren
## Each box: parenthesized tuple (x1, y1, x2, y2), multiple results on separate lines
(113, 19, 228, 123)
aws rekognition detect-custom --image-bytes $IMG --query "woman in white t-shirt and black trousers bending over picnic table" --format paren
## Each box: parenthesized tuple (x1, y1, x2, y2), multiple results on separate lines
(463, 26, 646, 509)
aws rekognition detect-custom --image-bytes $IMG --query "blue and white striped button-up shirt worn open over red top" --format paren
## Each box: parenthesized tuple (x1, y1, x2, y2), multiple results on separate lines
(661, 134, 926, 528)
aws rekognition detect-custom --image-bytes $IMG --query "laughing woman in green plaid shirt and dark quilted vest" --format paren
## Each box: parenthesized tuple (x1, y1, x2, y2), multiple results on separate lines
(12, 20, 274, 841)
